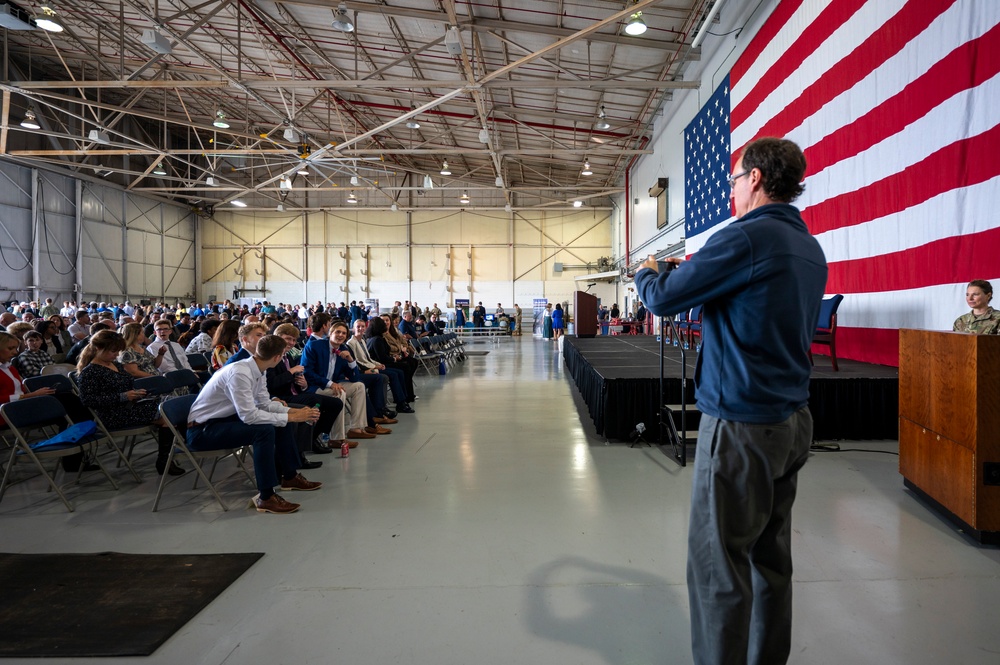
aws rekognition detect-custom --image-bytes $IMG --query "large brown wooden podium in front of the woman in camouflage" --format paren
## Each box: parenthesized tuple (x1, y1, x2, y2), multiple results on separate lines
(899, 329, 1000, 544)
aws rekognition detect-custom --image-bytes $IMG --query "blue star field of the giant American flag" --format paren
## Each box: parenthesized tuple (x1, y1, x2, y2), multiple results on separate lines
(684, 75, 732, 238)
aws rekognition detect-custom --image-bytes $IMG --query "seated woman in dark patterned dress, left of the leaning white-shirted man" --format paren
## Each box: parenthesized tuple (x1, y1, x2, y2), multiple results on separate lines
(76, 330, 184, 476)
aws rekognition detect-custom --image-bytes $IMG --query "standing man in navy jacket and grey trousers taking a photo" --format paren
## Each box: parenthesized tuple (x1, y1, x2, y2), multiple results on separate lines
(635, 138, 827, 665)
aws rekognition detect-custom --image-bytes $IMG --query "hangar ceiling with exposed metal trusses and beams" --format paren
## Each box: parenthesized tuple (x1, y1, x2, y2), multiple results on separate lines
(0, 0, 713, 214)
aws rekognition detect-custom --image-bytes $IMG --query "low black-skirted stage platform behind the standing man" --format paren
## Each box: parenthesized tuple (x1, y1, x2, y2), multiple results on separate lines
(563, 335, 899, 441)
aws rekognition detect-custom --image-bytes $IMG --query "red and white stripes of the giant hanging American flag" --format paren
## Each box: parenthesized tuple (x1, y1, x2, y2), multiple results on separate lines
(685, 0, 1000, 365)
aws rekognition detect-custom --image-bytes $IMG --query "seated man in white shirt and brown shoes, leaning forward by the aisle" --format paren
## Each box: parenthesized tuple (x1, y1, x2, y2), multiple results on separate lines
(187, 335, 322, 514)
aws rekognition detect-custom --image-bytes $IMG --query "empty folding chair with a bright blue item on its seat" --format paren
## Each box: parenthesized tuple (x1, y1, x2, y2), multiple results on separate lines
(0, 395, 118, 512)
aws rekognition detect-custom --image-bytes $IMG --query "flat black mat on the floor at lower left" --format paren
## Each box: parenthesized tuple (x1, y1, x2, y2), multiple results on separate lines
(0, 552, 264, 658)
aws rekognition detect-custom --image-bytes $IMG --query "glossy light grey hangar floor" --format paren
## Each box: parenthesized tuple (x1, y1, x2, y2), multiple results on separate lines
(0, 337, 1000, 665)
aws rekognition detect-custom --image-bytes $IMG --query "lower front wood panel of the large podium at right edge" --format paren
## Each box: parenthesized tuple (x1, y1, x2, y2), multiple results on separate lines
(899, 418, 968, 529)
